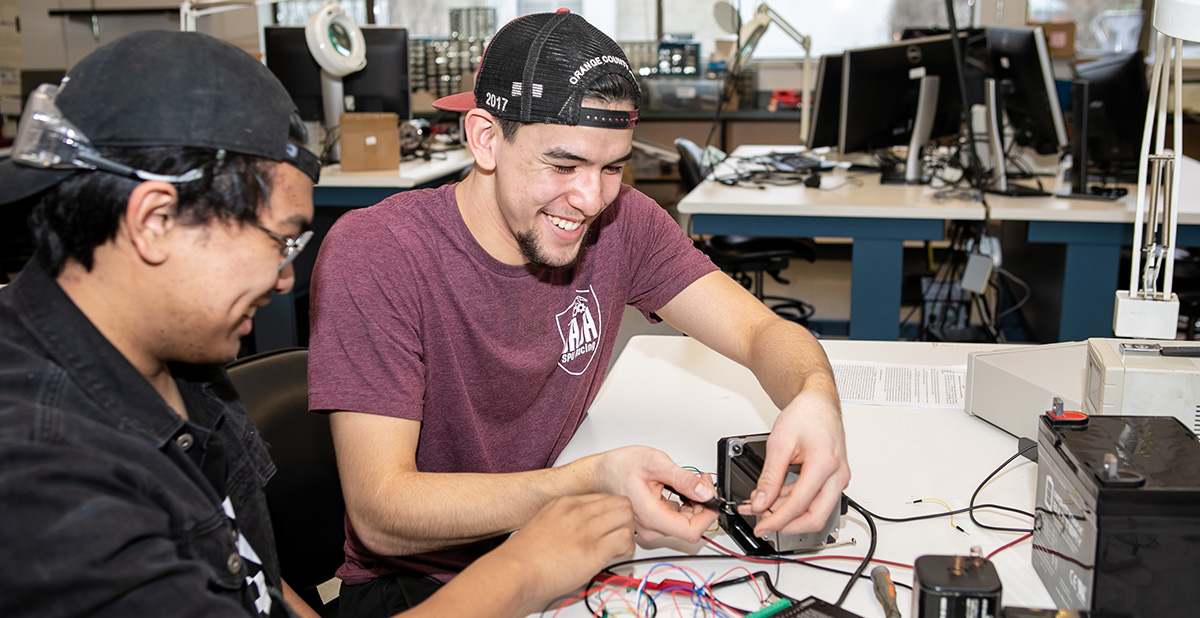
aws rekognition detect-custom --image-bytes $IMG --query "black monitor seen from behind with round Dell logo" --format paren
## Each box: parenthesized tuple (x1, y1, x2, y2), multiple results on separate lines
(838, 35, 962, 154)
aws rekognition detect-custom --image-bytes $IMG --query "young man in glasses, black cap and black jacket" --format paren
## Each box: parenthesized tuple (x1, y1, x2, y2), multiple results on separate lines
(0, 31, 632, 617)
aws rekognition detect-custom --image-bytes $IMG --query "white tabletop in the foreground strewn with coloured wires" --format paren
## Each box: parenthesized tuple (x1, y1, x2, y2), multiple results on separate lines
(547, 336, 1054, 618)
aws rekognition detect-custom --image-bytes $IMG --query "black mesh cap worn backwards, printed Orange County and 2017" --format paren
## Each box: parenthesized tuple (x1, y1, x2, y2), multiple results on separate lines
(433, 8, 641, 128)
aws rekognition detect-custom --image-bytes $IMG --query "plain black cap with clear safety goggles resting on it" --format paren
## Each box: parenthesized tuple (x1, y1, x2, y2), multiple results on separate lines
(0, 30, 320, 204)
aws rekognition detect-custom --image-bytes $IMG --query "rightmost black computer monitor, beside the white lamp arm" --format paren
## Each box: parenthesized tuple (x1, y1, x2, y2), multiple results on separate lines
(1075, 52, 1150, 182)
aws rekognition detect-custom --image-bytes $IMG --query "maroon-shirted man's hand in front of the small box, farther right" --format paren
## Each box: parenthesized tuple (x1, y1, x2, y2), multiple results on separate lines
(742, 389, 850, 535)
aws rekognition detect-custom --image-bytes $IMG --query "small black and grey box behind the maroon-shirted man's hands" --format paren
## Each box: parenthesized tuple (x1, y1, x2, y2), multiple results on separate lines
(716, 433, 846, 556)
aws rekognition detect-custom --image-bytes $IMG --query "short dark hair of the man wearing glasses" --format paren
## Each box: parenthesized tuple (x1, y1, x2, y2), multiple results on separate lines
(29, 118, 306, 274)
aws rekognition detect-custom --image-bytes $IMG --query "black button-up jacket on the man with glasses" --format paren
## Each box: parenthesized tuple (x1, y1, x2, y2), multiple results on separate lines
(0, 260, 290, 617)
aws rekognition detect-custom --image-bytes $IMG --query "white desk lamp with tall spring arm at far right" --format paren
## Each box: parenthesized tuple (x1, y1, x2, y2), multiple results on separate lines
(1112, 0, 1200, 340)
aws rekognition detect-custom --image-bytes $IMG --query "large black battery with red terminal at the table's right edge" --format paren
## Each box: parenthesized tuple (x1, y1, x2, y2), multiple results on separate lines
(1032, 415, 1200, 617)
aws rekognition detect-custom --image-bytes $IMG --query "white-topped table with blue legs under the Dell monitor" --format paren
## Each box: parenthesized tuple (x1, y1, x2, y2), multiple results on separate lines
(679, 145, 1200, 341)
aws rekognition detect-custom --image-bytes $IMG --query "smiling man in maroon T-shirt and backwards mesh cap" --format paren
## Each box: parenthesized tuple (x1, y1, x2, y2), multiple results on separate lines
(308, 11, 850, 616)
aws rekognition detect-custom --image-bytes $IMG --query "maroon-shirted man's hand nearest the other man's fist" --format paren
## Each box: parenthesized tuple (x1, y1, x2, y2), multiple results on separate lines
(595, 446, 716, 542)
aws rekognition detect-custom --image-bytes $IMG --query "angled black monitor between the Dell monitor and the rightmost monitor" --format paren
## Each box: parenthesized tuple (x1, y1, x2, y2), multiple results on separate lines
(988, 26, 1068, 155)
